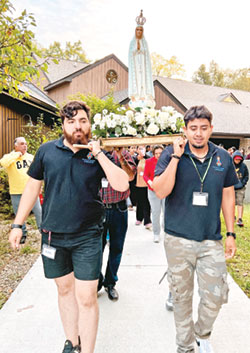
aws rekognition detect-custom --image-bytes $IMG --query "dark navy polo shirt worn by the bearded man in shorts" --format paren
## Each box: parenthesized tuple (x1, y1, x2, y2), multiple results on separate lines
(28, 138, 112, 233)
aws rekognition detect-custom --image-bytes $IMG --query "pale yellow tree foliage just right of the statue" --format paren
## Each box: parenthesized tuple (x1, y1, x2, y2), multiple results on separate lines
(151, 53, 185, 77)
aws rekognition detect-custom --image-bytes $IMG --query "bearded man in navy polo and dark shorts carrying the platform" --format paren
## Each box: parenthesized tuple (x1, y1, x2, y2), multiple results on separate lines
(9, 101, 129, 353)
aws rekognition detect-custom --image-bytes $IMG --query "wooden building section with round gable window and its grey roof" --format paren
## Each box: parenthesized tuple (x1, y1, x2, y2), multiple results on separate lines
(40, 54, 128, 104)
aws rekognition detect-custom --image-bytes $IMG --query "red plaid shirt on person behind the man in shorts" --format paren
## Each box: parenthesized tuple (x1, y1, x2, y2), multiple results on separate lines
(100, 150, 136, 203)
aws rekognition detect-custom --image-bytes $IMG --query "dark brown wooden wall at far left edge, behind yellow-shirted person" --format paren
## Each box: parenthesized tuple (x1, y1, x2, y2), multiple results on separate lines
(0, 104, 24, 158)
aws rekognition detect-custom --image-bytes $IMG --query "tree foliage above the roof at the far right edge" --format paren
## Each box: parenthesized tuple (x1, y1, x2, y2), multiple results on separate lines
(193, 61, 250, 91)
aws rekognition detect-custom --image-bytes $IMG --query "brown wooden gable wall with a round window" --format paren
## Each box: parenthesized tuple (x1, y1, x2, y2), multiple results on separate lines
(48, 58, 128, 104)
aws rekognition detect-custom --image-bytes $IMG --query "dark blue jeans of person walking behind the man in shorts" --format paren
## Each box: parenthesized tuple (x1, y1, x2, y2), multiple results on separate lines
(100, 202, 128, 287)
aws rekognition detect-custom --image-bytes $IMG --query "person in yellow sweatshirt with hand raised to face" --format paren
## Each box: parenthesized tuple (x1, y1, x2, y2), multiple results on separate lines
(0, 137, 42, 243)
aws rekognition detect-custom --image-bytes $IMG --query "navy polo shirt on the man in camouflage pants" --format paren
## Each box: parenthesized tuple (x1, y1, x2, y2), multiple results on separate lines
(155, 142, 238, 241)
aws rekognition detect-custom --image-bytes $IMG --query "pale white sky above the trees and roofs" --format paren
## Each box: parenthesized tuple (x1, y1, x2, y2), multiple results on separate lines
(11, 0, 250, 80)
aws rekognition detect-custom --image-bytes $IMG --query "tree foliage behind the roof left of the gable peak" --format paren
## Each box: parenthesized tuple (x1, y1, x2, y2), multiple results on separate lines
(42, 40, 89, 63)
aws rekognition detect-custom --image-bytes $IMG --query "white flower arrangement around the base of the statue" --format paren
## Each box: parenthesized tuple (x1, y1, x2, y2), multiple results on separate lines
(92, 106, 184, 138)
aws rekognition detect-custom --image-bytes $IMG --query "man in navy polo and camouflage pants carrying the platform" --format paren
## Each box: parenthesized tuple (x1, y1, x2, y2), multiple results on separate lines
(153, 106, 237, 353)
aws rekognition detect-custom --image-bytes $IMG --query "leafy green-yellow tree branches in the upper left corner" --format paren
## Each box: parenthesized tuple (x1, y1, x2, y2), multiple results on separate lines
(0, 0, 47, 98)
